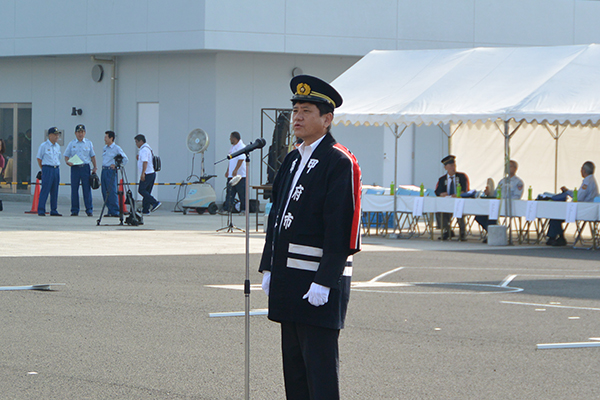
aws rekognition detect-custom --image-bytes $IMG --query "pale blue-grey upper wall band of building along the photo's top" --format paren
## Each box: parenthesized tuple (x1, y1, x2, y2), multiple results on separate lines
(5, 0, 600, 57)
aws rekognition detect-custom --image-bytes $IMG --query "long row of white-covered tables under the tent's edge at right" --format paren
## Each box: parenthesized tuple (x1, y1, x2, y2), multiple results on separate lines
(362, 194, 600, 248)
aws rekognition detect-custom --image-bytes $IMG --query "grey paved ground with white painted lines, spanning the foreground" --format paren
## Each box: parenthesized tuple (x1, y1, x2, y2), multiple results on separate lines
(0, 201, 600, 400)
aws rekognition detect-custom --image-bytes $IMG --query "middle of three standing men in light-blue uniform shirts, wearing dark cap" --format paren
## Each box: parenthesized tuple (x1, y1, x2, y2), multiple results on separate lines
(63, 125, 98, 217)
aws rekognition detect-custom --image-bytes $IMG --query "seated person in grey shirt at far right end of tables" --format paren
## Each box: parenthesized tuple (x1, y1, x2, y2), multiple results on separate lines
(546, 161, 598, 246)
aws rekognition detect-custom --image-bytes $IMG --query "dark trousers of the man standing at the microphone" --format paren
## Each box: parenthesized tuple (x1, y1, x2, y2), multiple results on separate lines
(281, 322, 340, 400)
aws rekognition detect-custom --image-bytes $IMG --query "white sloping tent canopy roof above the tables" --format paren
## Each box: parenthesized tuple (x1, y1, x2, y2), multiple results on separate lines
(332, 44, 600, 238)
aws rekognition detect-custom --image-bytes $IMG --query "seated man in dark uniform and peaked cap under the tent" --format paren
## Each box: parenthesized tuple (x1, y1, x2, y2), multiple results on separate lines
(435, 155, 470, 241)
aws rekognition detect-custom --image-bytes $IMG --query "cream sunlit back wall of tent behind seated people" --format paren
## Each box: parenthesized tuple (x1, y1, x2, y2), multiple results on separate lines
(452, 122, 600, 199)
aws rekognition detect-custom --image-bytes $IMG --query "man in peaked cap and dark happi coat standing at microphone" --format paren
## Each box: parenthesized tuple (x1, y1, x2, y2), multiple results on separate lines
(259, 75, 361, 400)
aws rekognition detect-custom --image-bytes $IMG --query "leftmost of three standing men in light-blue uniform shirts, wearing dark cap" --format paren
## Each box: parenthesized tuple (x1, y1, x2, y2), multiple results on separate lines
(37, 127, 62, 217)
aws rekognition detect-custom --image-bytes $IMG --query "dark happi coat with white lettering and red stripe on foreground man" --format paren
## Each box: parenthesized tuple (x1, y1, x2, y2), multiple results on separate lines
(259, 133, 361, 329)
